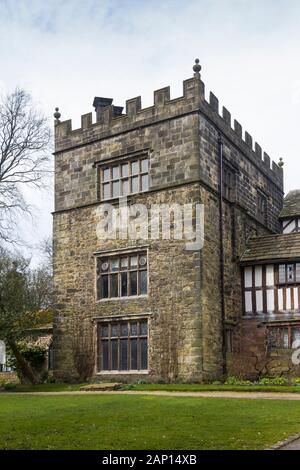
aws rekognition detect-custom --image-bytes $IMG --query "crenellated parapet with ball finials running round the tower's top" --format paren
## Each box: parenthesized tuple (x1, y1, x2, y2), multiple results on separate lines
(55, 67, 283, 188)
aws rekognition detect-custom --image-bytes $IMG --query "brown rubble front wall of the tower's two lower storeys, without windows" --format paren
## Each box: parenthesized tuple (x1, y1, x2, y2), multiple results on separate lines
(54, 185, 202, 380)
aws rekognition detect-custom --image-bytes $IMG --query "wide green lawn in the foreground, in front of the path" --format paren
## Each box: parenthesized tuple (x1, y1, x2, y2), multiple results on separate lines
(0, 394, 300, 450)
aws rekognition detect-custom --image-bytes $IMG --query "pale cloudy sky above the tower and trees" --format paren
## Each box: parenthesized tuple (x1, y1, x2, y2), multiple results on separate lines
(0, 0, 300, 262)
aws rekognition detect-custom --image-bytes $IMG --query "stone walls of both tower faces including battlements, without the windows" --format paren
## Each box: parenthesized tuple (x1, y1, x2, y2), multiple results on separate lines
(54, 71, 283, 381)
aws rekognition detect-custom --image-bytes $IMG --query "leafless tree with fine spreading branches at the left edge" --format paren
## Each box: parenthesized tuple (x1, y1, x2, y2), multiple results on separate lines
(0, 88, 51, 241)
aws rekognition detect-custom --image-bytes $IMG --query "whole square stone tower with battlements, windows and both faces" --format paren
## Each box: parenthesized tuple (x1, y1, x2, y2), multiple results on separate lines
(53, 61, 283, 381)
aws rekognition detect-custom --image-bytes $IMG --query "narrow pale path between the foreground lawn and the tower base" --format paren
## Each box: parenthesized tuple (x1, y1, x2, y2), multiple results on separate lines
(0, 390, 300, 400)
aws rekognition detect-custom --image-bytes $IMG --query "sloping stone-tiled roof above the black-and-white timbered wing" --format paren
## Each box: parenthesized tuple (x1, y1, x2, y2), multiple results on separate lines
(241, 232, 300, 264)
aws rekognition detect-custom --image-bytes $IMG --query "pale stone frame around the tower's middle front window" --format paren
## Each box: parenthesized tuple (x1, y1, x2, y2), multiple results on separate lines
(93, 245, 150, 303)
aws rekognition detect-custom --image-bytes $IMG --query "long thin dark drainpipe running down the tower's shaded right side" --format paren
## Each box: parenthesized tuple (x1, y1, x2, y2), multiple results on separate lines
(218, 134, 226, 376)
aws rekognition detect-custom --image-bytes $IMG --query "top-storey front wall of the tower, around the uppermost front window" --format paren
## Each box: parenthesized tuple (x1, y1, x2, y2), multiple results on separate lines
(55, 114, 199, 212)
